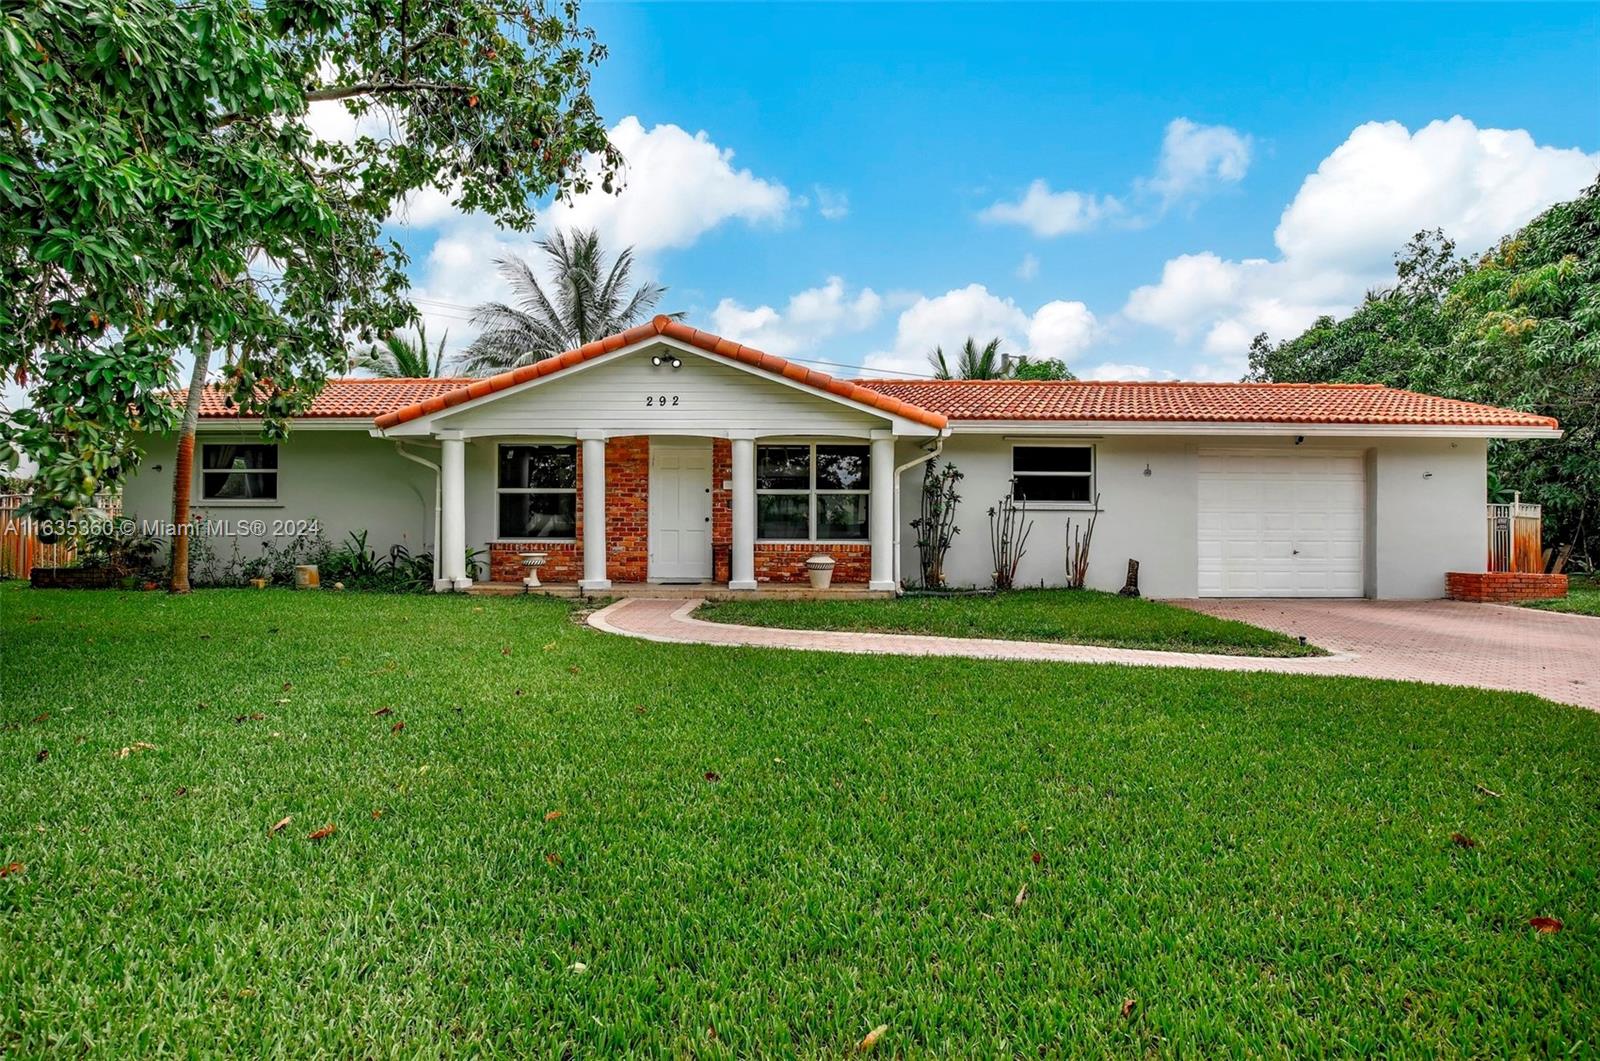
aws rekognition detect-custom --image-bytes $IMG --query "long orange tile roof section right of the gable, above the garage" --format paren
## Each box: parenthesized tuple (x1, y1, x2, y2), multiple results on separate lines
(856, 379, 1558, 427)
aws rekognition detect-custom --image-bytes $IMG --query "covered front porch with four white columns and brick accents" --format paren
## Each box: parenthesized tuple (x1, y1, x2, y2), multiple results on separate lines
(437, 429, 898, 597)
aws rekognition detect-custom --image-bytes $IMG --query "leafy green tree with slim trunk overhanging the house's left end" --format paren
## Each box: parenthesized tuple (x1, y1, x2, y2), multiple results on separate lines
(0, 0, 621, 591)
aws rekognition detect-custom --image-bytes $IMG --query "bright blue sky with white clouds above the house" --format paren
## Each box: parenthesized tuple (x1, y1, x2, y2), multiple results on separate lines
(387, 3, 1600, 378)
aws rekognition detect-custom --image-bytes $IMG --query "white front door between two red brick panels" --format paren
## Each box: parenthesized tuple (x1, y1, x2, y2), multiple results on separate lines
(650, 438, 710, 583)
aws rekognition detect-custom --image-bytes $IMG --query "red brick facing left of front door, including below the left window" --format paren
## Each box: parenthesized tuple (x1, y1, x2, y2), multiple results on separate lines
(490, 435, 650, 583)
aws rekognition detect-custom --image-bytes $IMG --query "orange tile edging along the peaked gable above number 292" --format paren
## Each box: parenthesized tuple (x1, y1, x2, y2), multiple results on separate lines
(378, 317, 946, 427)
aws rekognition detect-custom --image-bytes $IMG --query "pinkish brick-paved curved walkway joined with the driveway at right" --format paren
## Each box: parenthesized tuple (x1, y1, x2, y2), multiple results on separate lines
(589, 597, 1600, 711)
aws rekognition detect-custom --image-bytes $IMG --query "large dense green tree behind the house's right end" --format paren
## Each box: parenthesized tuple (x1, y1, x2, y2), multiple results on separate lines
(1250, 182, 1600, 563)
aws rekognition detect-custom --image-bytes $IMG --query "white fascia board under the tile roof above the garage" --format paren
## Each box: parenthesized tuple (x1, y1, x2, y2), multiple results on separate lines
(950, 419, 1562, 438)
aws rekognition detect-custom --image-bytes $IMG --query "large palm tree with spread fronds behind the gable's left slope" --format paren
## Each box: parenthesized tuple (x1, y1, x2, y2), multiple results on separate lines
(467, 229, 683, 376)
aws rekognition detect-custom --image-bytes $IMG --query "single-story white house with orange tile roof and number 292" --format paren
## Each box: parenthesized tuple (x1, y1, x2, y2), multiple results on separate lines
(125, 317, 1560, 599)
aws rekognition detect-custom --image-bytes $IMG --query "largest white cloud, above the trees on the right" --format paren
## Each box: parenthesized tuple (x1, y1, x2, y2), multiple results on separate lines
(1123, 117, 1600, 369)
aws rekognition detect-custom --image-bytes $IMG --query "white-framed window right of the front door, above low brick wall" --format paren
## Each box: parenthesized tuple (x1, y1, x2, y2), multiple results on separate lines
(755, 442, 872, 541)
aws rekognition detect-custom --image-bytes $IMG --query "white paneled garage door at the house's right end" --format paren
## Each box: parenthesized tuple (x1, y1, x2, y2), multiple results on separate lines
(1198, 450, 1366, 597)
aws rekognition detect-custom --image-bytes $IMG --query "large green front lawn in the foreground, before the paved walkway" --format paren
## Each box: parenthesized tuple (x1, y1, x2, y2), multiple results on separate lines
(0, 586, 1600, 1058)
